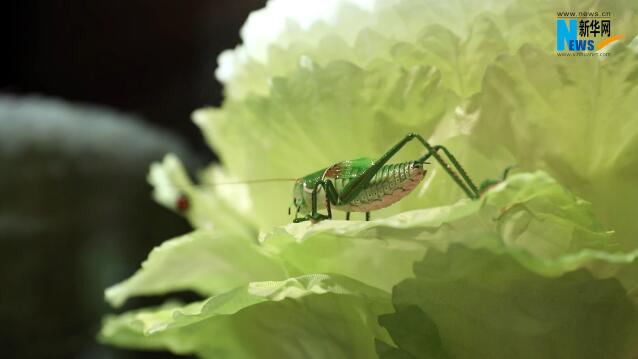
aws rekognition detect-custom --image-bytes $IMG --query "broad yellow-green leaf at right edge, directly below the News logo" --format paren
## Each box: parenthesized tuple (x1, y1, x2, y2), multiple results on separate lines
(467, 46, 638, 248)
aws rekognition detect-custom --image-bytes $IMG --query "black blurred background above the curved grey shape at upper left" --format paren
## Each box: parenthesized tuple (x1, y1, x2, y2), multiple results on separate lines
(0, 0, 265, 153)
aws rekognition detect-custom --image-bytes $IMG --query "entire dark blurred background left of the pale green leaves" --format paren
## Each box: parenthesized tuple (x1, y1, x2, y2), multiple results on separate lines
(0, 0, 265, 358)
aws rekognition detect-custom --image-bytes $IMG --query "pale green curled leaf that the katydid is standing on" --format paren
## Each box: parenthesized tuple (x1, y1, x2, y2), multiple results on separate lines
(251, 172, 624, 291)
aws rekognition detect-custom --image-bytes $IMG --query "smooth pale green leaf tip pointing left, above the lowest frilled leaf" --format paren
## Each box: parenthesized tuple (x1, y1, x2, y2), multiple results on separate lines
(106, 230, 287, 306)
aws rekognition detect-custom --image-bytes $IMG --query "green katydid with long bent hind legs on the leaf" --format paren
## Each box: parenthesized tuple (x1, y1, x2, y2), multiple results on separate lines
(186, 133, 513, 223)
